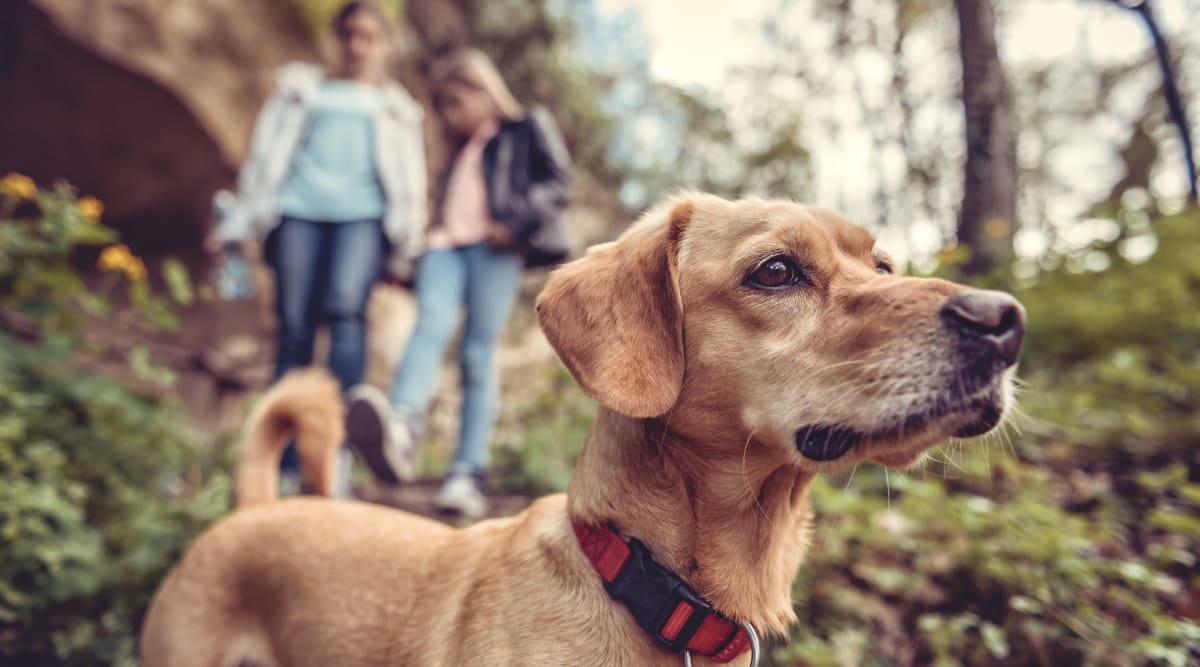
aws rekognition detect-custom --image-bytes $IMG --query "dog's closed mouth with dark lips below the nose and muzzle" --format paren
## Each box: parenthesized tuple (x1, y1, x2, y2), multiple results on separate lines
(796, 378, 1004, 463)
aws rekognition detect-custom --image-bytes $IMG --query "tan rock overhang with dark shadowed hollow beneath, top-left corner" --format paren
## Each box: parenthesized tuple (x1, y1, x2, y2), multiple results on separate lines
(0, 0, 314, 253)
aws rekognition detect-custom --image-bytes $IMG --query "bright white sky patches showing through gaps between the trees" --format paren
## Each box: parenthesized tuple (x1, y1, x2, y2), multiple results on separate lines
(598, 0, 1200, 263)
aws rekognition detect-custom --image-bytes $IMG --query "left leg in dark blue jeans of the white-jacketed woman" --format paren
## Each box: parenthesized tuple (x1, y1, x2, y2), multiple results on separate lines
(271, 217, 323, 475)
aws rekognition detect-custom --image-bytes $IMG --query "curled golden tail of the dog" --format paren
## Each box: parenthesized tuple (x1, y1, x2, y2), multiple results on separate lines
(235, 368, 346, 507)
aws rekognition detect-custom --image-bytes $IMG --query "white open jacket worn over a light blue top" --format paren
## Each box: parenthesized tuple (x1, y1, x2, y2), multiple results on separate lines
(216, 62, 428, 276)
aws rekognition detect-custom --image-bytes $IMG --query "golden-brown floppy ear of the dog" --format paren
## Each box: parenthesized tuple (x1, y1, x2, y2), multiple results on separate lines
(538, 199, 694, 417)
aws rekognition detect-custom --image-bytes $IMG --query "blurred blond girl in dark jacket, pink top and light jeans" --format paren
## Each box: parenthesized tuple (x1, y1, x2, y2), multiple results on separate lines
(347, 50, 570, 518)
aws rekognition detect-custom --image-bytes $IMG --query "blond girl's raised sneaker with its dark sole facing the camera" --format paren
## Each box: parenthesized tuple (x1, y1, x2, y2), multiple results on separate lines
(346, 384, 418, 483)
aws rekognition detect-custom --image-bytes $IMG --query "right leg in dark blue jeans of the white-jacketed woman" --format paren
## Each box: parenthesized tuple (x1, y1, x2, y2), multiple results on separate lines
(320, 221, 386, 391)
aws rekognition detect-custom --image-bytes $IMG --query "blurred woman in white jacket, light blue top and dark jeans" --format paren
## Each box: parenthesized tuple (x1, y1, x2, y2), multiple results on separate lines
(209, 1, 427, 494)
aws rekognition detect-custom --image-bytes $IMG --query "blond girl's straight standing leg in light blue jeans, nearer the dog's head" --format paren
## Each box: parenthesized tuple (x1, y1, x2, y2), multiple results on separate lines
(454, 244, 523, 474)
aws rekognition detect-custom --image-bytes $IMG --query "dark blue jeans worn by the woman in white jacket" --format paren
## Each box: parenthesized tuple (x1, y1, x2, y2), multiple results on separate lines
(269, 217, 388, 470)
